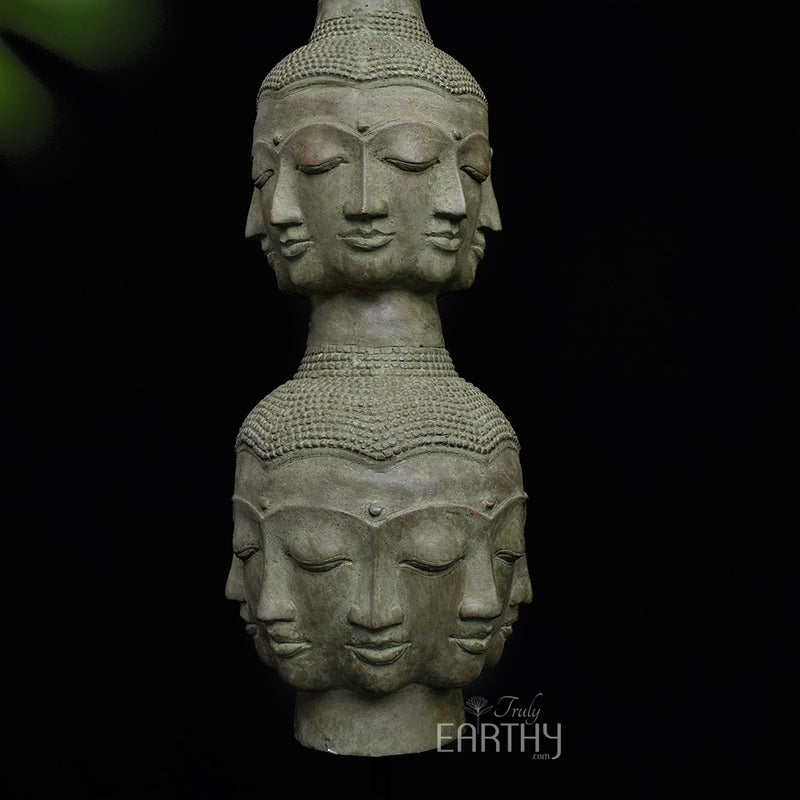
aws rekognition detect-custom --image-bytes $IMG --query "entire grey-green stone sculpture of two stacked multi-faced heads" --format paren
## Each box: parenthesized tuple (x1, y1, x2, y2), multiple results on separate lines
(227, 0, 531, 755)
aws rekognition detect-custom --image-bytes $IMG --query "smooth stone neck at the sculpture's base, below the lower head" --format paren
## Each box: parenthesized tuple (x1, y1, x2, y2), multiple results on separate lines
(294, 684, 464, 756)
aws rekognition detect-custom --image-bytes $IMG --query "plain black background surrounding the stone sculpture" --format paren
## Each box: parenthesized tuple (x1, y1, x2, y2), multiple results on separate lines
(2, 0, 796, 800)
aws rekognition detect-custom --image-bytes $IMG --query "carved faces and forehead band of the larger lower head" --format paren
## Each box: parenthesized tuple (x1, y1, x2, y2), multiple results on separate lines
(234, 451, 524, 694)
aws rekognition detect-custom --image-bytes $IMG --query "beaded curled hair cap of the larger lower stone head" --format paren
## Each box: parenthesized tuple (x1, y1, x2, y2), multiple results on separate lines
(236, 347, 519, 461)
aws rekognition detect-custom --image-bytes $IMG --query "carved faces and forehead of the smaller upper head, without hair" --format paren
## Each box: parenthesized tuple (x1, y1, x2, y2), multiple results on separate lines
(246, 86, 500, 293)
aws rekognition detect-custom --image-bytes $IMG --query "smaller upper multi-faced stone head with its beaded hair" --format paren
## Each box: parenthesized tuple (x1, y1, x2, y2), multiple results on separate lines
(246, 0, 500, 295)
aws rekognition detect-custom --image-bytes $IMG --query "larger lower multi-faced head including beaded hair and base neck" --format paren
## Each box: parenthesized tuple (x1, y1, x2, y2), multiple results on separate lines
(228, 348, 530, 754)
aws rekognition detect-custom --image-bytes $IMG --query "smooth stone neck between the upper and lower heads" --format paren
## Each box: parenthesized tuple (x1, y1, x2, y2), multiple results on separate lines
(307, 289, 444, 350)
